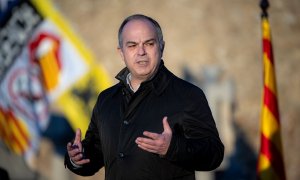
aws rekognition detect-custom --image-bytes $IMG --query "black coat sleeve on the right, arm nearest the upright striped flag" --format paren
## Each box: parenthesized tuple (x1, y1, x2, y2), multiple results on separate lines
(165, 88, 224, 171)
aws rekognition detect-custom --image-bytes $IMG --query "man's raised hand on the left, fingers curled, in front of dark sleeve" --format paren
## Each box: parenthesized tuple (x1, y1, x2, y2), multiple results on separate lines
(67, 129, 90, 166)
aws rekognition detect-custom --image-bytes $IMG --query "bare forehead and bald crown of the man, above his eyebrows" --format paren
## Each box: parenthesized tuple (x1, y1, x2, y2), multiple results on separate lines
(122, 19, 156, 38)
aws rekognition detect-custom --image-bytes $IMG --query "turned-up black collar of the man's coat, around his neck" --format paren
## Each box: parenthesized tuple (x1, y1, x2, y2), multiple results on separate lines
(115, 60, 172, 96)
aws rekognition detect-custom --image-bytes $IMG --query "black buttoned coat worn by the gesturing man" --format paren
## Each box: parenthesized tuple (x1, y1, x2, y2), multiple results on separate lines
(65, 61, 224, 180)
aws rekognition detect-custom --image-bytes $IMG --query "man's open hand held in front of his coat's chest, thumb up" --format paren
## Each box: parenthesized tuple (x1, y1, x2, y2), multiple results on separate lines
(135, 117, 172, 155)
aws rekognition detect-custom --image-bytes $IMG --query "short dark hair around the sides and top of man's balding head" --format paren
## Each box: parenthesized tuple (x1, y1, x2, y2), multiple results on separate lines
(118, 14, 165, 53)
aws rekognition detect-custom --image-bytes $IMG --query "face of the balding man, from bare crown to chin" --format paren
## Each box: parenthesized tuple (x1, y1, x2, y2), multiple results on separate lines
(119, 20, 161, 82)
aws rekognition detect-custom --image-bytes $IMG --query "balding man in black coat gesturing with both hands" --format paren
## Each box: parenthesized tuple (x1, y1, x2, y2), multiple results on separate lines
(65, 14, 224, 180)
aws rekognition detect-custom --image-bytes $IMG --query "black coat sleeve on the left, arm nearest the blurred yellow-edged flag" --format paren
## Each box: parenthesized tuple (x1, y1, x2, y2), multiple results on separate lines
(65, 95, 104, 176)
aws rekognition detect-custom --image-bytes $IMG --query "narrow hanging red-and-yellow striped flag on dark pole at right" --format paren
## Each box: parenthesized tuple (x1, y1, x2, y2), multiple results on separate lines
(257, 0, 286, 180)
